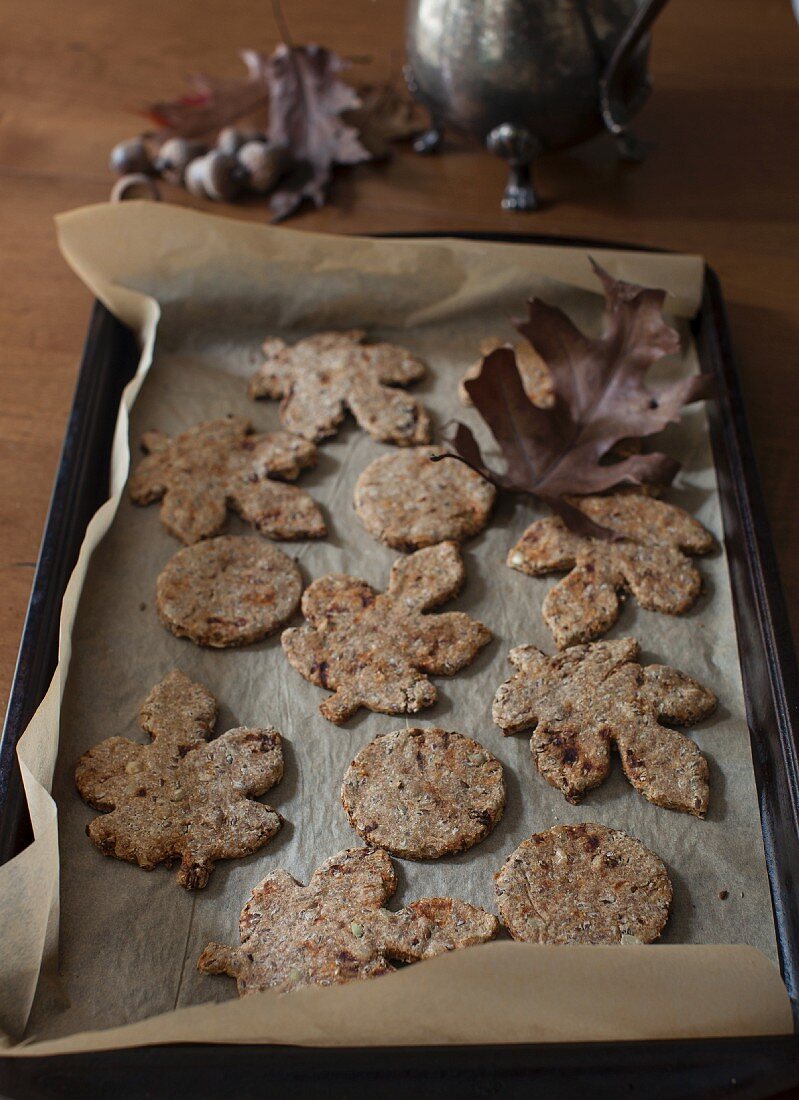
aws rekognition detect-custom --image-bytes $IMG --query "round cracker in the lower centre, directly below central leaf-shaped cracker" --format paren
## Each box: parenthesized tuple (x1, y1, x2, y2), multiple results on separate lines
(341, 727, 505, 859)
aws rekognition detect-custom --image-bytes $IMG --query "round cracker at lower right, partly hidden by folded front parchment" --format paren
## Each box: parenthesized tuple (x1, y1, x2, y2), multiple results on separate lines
(495, 823, 671, 944)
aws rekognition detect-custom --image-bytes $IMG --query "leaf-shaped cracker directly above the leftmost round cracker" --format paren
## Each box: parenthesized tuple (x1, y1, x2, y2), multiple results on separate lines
(129, 416, 327, 545)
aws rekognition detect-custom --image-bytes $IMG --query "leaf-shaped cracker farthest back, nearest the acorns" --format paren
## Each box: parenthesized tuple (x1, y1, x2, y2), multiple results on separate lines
(250, 329, 430, 446)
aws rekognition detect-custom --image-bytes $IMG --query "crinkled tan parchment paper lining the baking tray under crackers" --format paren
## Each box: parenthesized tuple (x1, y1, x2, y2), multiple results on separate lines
(0, 204, 790, 1054)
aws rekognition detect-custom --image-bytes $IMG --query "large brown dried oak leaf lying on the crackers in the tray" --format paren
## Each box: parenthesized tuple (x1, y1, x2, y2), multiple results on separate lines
(441, 261, 710, 537)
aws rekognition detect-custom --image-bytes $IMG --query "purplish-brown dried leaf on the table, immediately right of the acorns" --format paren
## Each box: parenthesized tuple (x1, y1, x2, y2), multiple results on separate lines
(265, 45, 372, 221)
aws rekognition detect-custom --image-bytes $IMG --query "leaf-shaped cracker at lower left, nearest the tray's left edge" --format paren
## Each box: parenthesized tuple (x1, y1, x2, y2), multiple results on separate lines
(75, 671, 283, 890)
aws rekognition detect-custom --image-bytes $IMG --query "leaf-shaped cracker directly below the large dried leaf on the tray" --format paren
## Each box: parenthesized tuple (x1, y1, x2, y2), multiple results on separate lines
(507, 491, 713, 649)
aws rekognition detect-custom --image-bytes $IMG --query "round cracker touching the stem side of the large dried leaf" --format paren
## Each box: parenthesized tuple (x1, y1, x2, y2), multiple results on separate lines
(354, 447, 496, 550)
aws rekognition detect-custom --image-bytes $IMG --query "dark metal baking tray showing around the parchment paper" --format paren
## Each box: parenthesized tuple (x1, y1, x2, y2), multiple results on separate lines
(0, 233, 799, 1098)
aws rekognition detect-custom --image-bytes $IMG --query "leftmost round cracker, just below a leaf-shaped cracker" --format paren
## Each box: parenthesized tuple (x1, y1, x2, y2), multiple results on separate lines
(155, 535, 303, 649)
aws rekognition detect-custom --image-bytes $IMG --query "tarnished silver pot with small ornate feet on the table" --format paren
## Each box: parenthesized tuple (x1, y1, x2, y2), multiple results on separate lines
(406, 0, 667, 210)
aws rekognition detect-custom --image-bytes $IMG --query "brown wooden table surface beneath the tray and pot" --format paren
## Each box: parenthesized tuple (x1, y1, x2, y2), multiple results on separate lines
(0, 0, 799, 705)
